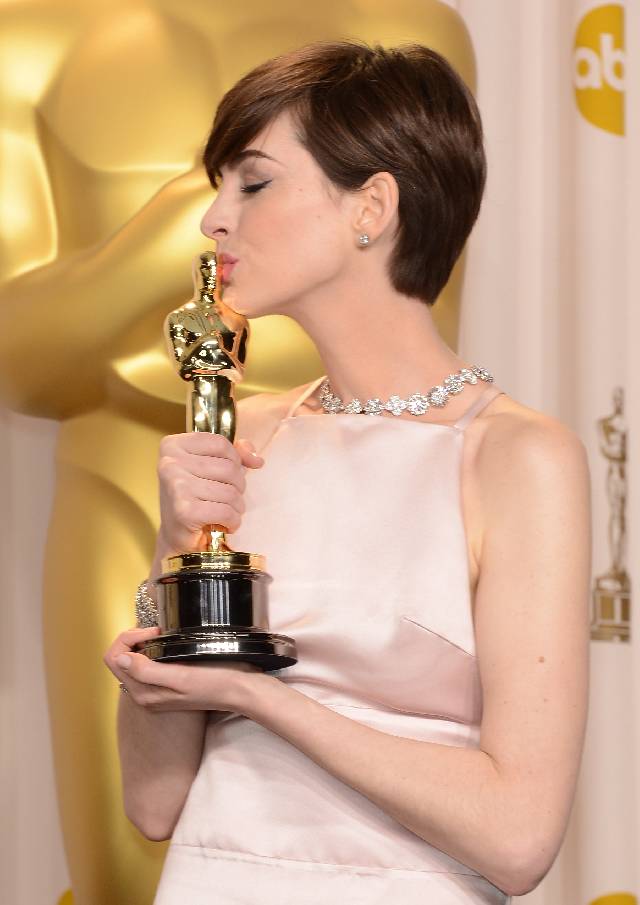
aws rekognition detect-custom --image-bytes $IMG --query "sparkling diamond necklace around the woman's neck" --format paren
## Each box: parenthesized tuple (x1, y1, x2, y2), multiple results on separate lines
(320, 365, 493, 415)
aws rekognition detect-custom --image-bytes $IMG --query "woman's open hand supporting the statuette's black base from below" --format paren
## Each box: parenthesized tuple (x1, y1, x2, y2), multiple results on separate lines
(104, 627, 269, 713)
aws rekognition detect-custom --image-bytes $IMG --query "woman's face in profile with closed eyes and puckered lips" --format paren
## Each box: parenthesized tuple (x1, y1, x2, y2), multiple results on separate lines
(201, 114, 357, 317)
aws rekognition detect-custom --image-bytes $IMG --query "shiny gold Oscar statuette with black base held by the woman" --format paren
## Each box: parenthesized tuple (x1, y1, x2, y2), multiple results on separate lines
(139, 251, 297, 670)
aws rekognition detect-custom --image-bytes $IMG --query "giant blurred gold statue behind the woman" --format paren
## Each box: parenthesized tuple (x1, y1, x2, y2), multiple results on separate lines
(0, 0, 474, 905)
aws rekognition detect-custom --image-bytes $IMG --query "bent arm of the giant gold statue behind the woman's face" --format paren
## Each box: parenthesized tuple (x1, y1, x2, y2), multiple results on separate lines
(0, 168, 211, 418)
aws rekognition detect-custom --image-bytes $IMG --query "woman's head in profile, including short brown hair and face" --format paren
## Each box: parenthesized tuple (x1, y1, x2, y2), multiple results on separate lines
(202, 42, 486, 316)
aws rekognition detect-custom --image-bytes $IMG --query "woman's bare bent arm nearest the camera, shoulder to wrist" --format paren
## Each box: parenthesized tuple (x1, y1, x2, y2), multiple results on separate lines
(234, 419, 590, 895)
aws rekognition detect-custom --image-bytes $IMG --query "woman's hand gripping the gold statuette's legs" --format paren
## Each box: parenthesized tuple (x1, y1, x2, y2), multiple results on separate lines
(158, 432, 264, 555)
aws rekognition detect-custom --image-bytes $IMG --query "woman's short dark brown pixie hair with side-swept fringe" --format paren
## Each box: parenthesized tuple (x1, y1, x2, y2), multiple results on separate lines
(203, 42, 486, 304)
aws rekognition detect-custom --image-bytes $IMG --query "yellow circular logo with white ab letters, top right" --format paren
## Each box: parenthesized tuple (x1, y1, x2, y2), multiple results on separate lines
(573, 3, 625, 135)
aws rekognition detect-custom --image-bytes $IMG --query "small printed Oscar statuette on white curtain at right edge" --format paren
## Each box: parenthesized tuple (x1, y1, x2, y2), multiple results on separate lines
(591, 387, 631, 641)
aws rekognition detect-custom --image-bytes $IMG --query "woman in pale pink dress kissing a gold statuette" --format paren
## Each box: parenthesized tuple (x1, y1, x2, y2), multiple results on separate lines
(105, 44, 589, 905)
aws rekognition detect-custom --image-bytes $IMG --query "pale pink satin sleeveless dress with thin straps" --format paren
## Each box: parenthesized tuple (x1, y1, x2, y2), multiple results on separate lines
(155, 380, 509, 905)
